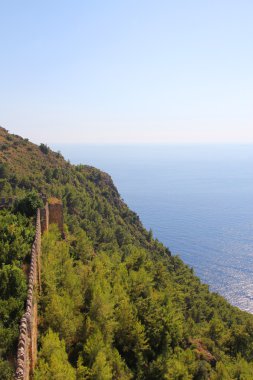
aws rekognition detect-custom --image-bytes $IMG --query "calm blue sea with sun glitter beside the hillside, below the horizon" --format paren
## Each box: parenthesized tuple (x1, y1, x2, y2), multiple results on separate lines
(54, 145, 253, 313)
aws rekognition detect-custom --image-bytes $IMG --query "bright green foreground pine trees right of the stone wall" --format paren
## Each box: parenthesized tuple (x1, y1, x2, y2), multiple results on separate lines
(33, 228, 253, 379)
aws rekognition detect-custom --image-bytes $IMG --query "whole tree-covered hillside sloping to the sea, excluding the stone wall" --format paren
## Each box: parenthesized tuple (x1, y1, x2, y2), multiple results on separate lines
(0, 128, 253, 380)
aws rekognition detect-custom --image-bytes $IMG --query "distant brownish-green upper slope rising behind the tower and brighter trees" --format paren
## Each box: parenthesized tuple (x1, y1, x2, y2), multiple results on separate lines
(0, 127, 158, 251)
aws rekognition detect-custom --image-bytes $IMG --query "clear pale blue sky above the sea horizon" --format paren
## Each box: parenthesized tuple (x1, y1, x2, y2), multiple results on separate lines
(0, 0, 253, 143)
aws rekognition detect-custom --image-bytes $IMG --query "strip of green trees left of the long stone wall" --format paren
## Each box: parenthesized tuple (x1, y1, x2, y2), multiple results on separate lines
(0, 210, 34, 380)
